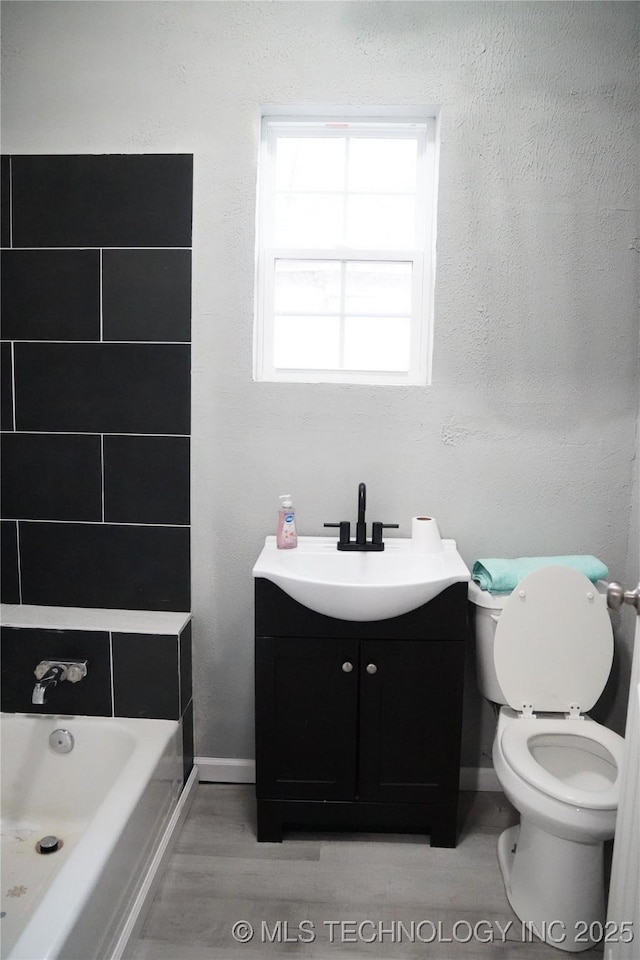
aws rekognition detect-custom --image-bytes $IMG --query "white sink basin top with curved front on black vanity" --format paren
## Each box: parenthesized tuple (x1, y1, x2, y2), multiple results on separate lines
(253, 537, 470, 621)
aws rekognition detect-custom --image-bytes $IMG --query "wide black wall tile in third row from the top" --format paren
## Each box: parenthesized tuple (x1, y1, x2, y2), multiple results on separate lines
(15, 343, 191, 434)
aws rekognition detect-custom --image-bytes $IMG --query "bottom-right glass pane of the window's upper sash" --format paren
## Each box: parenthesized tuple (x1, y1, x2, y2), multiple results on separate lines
(347, 194, 415, 250)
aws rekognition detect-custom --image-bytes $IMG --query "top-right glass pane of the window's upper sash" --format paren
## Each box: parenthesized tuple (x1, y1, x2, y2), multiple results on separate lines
(349, 137, 418, 193)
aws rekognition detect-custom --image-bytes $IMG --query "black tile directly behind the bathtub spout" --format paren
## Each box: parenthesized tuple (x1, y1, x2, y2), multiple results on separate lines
(2, 627, 112, 717)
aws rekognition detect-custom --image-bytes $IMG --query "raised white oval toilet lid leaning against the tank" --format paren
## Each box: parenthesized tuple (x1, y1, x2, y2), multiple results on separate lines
(494, 567, 613, 713)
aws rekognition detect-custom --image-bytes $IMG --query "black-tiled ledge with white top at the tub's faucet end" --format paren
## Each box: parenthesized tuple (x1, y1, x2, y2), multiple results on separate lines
(0, 604, 193, 780)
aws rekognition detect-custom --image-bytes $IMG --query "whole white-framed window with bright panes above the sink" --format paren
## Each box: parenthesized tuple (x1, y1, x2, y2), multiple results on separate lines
(254, 117, 436, 384)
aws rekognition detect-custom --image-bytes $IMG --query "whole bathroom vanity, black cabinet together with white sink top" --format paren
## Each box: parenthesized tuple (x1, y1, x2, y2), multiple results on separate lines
(254, 537, 469, 847)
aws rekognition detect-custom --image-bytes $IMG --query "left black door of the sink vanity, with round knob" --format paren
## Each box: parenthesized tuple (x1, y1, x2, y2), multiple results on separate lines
(256, 637, 358, 800)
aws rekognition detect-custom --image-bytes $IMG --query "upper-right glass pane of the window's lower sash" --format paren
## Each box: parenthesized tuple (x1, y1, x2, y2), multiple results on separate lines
(345, 260, 413, 316)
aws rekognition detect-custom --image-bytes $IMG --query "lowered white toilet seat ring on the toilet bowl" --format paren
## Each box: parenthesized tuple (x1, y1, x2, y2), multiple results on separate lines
(501, 717, 624, 810)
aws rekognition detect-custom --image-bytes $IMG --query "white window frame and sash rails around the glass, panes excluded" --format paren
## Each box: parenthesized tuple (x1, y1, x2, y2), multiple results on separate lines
(254, 115, 437, 386)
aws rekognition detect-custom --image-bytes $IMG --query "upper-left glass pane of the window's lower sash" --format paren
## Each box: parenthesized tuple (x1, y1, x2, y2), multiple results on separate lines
(274, 260, 342, 314)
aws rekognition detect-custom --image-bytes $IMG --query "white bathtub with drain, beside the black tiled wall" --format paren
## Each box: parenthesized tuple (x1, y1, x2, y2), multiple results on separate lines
(0, 714, 182, 960)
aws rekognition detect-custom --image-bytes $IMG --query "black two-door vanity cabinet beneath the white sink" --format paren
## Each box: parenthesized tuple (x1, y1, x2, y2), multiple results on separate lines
(255, 578, 467, 847)
